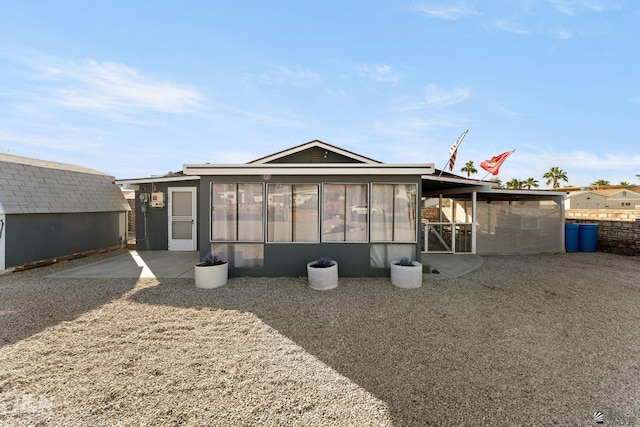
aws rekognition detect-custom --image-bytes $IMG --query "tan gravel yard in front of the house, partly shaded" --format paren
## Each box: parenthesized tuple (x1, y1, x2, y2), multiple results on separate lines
(0, 252, 640, 426)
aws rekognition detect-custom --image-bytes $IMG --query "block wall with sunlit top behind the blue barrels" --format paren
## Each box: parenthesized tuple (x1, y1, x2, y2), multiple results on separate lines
(565, 206, 640, 256)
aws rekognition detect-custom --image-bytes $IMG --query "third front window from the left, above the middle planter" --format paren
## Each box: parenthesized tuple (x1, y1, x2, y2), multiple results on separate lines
(322, 184, 368, 242)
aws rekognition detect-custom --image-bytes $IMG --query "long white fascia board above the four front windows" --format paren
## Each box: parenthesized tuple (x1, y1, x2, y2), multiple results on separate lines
(182, 163, 435, 176)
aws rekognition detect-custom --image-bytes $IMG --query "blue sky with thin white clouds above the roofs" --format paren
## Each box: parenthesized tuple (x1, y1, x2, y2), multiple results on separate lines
(0, 0, 640, 188)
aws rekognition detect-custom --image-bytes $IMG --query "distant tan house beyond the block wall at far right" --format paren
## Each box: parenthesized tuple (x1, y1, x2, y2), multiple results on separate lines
(565, 186, 640, 209)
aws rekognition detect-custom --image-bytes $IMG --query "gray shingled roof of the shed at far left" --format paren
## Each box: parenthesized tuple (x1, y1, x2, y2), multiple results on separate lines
(0, 153, 130, 214)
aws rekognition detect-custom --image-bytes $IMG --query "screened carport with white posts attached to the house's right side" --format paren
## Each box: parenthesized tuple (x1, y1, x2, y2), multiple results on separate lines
(421, 171, 565, 255)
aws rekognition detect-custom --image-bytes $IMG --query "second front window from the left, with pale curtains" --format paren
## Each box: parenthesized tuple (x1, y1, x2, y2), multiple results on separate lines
(267, 184, 318, 242)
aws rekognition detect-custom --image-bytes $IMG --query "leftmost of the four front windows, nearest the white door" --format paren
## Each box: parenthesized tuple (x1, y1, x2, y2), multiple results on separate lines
(211, 183, 264, 242)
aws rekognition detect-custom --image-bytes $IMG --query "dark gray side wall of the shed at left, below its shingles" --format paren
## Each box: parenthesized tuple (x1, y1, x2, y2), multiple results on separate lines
(4, 212, 121, 268)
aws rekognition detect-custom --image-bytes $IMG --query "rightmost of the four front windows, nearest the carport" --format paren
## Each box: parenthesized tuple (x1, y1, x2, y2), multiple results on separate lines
(371, 184, 417, 242)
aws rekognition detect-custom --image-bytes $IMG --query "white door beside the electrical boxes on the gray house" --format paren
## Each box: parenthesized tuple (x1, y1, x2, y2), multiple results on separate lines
(167, 187, 197, 251)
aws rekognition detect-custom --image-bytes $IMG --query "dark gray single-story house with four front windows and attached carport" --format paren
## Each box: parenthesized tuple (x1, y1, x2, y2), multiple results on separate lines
(118, 140, 564, 277)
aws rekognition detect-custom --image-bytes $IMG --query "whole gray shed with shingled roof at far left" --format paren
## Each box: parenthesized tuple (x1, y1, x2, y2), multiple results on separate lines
(0, 153, 130, 270)
